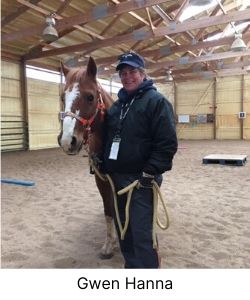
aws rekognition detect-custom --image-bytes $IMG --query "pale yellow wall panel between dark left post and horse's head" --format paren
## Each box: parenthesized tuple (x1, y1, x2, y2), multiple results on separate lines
(27, 78, 60, 150)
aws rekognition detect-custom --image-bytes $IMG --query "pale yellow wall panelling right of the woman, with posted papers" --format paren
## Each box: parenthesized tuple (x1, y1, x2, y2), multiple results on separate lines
(175, 75, 250, 140)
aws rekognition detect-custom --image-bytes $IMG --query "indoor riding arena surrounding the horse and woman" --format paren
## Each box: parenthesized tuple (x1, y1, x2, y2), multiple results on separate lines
(1, 0, 250, 269)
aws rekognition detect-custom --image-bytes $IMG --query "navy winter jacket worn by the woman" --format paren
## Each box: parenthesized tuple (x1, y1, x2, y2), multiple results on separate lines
(103, 80, 177, 175)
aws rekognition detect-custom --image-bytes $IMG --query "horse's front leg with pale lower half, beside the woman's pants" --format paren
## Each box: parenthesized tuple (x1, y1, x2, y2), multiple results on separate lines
(95, 175, 116, 259)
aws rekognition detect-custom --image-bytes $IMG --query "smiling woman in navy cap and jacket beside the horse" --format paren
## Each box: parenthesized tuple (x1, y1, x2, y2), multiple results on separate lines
(104, 52, 177, 268)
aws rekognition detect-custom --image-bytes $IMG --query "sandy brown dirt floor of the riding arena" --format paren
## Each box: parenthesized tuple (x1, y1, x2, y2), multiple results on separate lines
(1, 141, 250, 268)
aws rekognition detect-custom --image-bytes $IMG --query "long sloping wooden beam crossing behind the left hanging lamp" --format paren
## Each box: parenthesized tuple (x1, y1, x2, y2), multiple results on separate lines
(2, 0, 172, 42)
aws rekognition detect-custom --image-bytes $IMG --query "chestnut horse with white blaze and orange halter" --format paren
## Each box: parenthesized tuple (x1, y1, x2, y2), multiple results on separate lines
(58, 57, 116, 259)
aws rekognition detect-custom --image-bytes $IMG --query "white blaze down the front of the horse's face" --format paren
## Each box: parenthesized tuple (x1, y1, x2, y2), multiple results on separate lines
(61, 83, 80, 151)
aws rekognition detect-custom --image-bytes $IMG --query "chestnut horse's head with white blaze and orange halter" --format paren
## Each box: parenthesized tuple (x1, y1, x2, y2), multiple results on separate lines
(58, 57, 105, 154)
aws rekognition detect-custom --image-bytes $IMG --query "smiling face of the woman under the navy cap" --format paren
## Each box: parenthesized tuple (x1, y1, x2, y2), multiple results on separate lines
(119, 65, 145, 93)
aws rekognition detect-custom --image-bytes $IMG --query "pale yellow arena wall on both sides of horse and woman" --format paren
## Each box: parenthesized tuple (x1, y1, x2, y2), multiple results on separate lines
(1, 61, 250, 151)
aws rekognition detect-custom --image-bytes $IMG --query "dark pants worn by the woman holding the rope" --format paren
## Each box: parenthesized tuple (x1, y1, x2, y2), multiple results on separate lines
(111, 173, 162, 268)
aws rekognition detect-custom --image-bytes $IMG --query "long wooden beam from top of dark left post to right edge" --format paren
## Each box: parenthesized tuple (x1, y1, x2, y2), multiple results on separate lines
(25, 9, 250, 59)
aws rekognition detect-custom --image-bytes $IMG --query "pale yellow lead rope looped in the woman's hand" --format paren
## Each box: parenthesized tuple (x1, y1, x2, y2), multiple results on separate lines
(90, 160, 170, 249)
